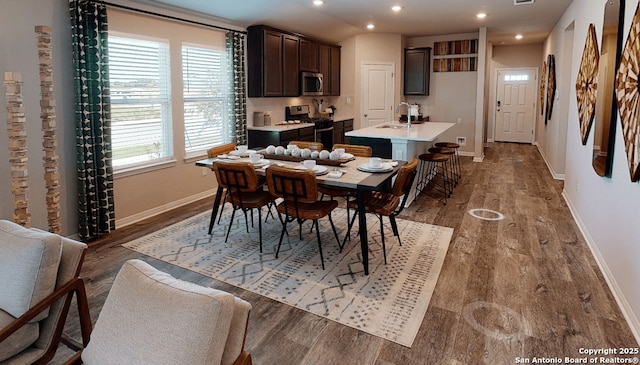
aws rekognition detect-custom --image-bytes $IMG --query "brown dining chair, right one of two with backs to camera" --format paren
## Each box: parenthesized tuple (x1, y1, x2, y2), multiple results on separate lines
(266, 166, 341, 270)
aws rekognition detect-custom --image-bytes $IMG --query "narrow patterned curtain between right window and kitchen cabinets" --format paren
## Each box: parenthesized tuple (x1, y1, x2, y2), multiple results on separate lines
(227, 32, 247, 144)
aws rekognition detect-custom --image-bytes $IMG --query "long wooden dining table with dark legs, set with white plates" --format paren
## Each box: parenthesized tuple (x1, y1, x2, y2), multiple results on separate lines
(195, 152, 406, 275)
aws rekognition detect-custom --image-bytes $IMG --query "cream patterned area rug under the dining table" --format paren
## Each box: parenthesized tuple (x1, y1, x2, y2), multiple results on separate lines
(123, 206, 453, 347)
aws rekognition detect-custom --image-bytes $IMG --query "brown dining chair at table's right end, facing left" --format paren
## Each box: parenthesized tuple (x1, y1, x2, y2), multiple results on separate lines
(345, 157, 418, 264)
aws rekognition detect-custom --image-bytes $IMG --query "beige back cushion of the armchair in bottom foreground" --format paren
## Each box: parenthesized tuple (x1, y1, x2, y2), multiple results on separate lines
(82, 260, 235, 365)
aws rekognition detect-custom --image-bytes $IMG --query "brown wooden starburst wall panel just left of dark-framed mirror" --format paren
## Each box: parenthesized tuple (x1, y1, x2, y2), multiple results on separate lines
(576, 23, 600, 145)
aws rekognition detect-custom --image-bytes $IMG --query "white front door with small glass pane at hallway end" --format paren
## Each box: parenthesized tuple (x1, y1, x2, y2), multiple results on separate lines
(495, 68, 537, 143)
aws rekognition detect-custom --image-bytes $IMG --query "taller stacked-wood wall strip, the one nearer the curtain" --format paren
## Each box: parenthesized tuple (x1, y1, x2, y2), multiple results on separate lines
(35, 26, 62, 234)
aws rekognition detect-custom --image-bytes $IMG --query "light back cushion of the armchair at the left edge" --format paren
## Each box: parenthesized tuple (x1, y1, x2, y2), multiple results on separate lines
(0, 220, 62, 322)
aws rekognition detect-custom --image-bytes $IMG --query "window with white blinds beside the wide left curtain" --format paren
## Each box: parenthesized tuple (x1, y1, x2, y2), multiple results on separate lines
(109, 34, 173, 170)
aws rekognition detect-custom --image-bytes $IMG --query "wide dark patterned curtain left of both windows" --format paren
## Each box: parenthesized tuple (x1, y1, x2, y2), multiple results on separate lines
(69, 0, 115, 241)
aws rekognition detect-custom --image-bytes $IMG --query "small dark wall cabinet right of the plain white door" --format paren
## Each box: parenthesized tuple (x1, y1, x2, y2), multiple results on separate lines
(404, 47, 431, 95)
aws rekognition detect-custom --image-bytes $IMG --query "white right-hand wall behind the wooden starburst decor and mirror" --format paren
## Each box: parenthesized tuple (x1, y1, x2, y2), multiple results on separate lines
(539, 0, 640, 338)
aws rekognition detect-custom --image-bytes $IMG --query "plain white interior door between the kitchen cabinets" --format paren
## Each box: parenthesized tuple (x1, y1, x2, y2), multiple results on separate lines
(360, 63, 395, 128)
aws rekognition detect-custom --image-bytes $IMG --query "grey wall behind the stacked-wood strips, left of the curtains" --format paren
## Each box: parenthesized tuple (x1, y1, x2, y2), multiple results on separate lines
(0, 0, 78, 234)
